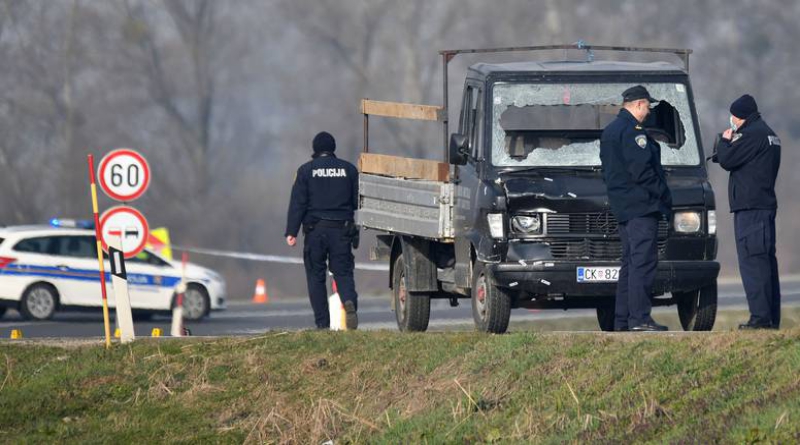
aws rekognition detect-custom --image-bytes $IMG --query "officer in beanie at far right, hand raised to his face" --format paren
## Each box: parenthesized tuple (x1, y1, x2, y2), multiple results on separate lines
(713, 94, 781, 329)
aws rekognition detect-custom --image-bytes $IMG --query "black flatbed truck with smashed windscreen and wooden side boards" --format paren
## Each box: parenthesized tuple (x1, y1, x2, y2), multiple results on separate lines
(356, 43, 719, 333)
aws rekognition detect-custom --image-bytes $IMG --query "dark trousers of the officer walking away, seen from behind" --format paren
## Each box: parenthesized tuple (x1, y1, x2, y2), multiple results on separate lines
(303, 226, 358, 328)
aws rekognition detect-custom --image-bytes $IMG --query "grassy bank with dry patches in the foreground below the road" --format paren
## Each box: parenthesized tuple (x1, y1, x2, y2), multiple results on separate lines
(0, 318, 800, 444)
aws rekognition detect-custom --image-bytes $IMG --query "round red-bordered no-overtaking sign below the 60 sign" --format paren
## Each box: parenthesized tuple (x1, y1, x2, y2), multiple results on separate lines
(100, 206, 150, 259)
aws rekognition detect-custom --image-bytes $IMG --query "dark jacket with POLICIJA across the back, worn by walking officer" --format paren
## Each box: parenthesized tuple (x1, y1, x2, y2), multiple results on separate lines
(285, 153, 358, 236)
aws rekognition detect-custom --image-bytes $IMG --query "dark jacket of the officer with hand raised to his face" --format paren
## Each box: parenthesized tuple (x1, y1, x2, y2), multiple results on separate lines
(717, 113, 781, 212)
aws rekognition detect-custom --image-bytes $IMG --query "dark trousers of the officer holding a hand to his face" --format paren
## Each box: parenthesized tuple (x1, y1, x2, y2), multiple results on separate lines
(733, 210, 781, 328)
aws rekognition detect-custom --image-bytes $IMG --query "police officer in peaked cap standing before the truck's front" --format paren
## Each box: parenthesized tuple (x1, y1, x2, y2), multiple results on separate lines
(600, 85, 672, 331)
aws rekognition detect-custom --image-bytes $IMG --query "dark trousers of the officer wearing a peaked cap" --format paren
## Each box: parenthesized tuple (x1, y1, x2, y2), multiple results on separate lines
(614, 215, 659, 331)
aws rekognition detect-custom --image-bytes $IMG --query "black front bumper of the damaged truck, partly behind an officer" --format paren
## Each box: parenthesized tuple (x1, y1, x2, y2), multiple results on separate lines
(487, 260, 719, 297)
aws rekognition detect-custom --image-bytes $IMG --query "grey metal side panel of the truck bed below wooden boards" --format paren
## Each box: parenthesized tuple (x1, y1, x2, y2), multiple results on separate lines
(356, 173, 453, 240)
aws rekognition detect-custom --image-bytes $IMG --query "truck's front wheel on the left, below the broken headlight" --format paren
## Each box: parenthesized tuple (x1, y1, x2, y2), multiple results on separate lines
(472, 261, 511, 334)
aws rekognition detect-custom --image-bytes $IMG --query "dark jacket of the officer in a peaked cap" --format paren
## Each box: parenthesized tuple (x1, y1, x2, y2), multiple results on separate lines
(600, 108, 672, 222)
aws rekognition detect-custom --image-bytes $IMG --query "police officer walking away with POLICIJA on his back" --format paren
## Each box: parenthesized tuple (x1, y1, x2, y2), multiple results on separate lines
(285, 132, 358, 329)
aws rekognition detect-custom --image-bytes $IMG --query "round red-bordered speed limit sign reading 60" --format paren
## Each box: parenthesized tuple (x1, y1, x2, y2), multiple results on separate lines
(97, 148, 150, 202)
